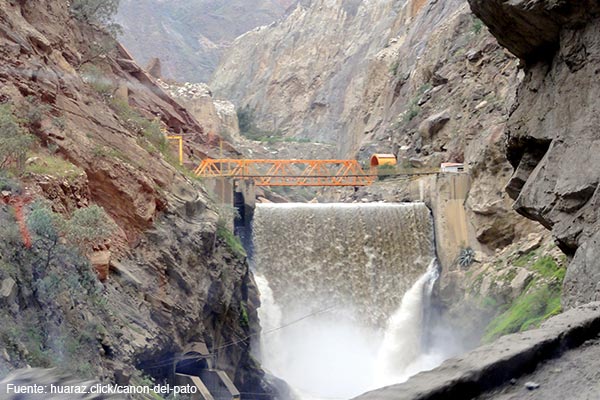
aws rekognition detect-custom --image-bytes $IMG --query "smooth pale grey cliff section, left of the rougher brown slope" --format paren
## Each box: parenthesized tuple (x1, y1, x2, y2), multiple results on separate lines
(211, 0, 412, 151)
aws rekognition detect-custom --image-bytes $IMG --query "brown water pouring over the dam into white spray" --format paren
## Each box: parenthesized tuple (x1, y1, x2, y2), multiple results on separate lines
(253, 203, 446, 399)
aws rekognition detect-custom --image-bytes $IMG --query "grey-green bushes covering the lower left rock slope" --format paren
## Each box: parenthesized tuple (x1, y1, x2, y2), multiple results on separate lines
(0, 203, 116, 377)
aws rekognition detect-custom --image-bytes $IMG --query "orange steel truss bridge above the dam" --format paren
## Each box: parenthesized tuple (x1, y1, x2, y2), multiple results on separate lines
(194, 159, 377, 186)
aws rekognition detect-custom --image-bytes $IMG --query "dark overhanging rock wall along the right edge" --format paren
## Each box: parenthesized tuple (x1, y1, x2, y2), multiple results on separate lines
(469, 0, 600, 306)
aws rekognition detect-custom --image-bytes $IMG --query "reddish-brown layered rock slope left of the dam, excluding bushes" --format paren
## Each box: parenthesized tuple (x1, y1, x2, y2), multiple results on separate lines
(0, 0, 270, 397)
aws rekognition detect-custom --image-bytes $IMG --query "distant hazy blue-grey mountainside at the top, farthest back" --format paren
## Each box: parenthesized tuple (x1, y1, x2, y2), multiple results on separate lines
(117, 0, 295, 82)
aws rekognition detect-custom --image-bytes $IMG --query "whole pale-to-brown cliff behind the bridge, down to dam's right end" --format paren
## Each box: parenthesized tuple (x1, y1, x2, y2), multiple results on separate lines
(241, 1, 534, 253)
